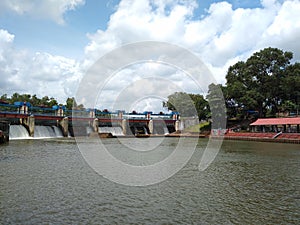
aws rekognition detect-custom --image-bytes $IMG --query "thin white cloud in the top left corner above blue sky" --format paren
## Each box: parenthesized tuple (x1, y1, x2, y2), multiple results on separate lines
(0, 0, 85, 24)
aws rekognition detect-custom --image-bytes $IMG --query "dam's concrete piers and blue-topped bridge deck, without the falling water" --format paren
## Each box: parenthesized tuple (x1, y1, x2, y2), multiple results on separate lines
(0, 102, 180, 137)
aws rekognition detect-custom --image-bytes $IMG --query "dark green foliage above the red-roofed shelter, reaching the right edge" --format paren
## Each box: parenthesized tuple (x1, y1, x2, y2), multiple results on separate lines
(225, 48, 300, 117)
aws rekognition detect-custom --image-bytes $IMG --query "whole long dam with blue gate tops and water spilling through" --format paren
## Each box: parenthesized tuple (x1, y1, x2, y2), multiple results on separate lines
(0, 102, 182, 139)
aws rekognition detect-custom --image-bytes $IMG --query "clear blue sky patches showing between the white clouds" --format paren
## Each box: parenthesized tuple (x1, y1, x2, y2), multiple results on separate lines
(0, 0, 261, 58)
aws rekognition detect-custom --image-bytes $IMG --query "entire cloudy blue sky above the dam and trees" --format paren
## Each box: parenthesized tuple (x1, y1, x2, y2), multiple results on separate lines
(0, 0, 300, 112)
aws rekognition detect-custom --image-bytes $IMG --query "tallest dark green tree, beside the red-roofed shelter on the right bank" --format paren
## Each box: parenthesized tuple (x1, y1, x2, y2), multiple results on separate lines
(226, 48, 293, 117)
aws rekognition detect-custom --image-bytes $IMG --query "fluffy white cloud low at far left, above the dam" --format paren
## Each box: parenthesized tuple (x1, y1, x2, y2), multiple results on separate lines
(0, 30, 82, 102)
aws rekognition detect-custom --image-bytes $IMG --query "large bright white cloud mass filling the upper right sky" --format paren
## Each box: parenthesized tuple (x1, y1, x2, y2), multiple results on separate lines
(81, 0, 300, 110)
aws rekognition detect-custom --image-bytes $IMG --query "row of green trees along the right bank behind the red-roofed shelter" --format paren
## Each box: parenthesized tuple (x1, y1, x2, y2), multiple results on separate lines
(163, 47, 300, 119)
